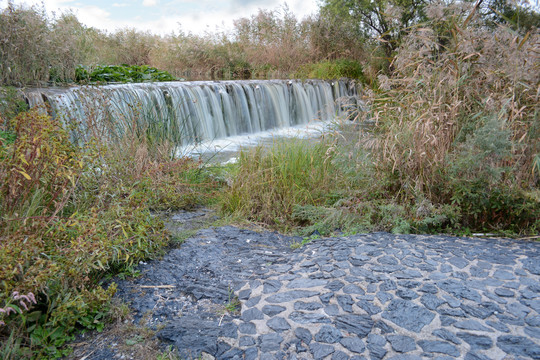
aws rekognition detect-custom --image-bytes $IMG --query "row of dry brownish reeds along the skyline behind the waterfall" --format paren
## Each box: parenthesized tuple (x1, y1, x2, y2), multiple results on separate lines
(0, 3, 365, 86)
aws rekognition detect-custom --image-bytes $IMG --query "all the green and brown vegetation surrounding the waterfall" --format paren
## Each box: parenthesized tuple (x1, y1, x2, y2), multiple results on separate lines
(0, 0, 540, 359)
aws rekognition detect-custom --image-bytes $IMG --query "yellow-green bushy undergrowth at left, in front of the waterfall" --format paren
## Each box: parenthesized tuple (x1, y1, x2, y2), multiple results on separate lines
(0, 111, 217, 359)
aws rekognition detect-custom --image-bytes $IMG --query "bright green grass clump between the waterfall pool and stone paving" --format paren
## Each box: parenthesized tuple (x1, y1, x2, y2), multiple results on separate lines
(222, 140, 352, 231)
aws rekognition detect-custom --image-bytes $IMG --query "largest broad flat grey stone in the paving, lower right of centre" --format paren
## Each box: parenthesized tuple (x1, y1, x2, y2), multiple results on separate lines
(382, 299, 435, 332)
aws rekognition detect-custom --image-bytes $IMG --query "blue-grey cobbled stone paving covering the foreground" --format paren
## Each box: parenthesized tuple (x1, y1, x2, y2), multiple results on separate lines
(115, 221, 540, 360)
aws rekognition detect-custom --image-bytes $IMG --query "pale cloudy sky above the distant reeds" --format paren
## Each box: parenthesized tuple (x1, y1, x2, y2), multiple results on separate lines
(0, 0, 318, 35)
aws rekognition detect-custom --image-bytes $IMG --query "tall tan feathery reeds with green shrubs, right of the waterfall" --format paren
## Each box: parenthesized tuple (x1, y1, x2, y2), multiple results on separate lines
(365, 4, 540, 232)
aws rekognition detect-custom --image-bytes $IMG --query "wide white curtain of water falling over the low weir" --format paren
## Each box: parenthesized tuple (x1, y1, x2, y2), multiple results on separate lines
(27, 80, 359, 145)
